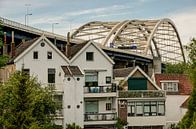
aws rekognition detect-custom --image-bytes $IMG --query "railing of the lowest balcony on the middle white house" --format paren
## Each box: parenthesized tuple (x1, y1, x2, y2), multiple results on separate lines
(84, 113, 117, 121)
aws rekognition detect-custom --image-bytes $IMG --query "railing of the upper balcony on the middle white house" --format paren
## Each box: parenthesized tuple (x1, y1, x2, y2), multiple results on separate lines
(84, 85, 116, 93)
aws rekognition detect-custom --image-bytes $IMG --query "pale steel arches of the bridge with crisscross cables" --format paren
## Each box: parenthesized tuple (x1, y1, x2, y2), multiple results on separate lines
(71, 19, 185, 63)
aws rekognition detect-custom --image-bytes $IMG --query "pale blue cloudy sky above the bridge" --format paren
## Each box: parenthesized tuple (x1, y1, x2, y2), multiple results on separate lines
(0, 0, 196, 44)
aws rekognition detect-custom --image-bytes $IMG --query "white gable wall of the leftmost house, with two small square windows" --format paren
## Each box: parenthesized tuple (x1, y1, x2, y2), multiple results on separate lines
(15, 41, 68, 83)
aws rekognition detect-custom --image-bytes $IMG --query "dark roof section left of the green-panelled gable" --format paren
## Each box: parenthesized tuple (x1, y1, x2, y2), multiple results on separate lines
(113, 67, 134, 77)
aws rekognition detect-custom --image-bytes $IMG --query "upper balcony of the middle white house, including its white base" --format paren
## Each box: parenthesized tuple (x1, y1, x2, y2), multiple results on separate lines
(84, 85, 117, 97)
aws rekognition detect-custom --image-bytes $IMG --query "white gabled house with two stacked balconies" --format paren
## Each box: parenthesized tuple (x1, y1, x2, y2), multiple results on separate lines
(70, 42, 117, 128)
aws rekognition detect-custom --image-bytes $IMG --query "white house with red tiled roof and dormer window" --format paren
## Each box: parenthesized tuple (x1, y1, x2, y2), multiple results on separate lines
(155, 74, 192, 128)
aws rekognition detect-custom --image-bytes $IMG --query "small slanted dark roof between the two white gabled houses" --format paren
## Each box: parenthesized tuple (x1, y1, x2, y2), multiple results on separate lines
(61, 66, 83, 76)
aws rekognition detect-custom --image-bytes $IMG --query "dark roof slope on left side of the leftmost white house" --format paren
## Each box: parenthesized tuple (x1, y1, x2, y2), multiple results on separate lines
(8, 37, 39, 63)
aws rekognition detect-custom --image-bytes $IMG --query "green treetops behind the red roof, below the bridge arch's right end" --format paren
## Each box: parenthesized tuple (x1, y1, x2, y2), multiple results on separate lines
(164, 62, 189, 74)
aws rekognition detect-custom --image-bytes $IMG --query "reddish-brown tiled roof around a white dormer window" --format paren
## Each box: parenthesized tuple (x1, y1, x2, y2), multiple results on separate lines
(155, 74, 192, 95)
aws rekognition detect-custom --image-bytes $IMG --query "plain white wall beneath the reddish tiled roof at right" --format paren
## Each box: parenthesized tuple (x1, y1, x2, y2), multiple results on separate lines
(166, 95, 189, 126)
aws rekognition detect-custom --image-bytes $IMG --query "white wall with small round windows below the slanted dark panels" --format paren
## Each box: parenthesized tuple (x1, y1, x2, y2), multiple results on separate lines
(63, 76, 84, 128)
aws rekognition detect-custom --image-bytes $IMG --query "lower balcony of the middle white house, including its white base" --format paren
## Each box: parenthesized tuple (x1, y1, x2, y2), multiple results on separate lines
(84, 113, 117, 125)
